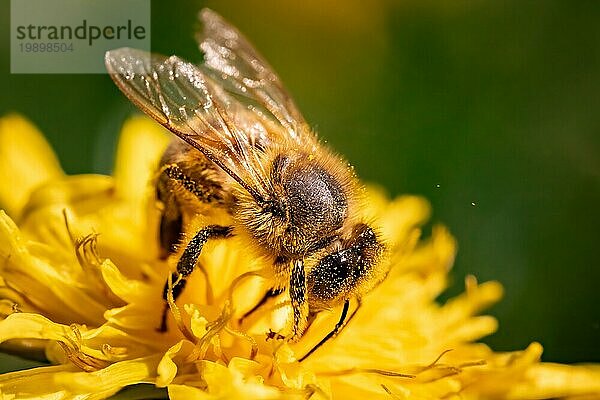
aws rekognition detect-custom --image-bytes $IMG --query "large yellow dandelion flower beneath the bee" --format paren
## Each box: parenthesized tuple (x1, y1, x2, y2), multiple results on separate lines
(0, 115, 600, 399)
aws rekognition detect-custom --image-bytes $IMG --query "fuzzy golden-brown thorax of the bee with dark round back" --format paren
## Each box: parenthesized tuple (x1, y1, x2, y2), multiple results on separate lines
(237, 158, 348, 259)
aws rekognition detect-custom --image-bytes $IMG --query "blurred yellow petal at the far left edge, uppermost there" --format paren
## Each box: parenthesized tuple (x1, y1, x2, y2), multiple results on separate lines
(0, 114, 63, 218)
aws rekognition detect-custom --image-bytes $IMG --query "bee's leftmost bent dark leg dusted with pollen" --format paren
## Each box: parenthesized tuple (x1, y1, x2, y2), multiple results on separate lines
(159, 225, 232, 332)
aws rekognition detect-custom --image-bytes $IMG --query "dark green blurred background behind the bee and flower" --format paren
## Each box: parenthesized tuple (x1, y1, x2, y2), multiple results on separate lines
(0, 0, 600, 370)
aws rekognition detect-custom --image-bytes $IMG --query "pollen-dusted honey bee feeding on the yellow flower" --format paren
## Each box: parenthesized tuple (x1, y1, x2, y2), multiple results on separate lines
(105, 9, 387, 351)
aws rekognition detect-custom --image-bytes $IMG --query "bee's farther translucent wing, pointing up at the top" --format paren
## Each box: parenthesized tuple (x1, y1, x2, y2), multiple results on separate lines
(196, 9, 315, 148)
